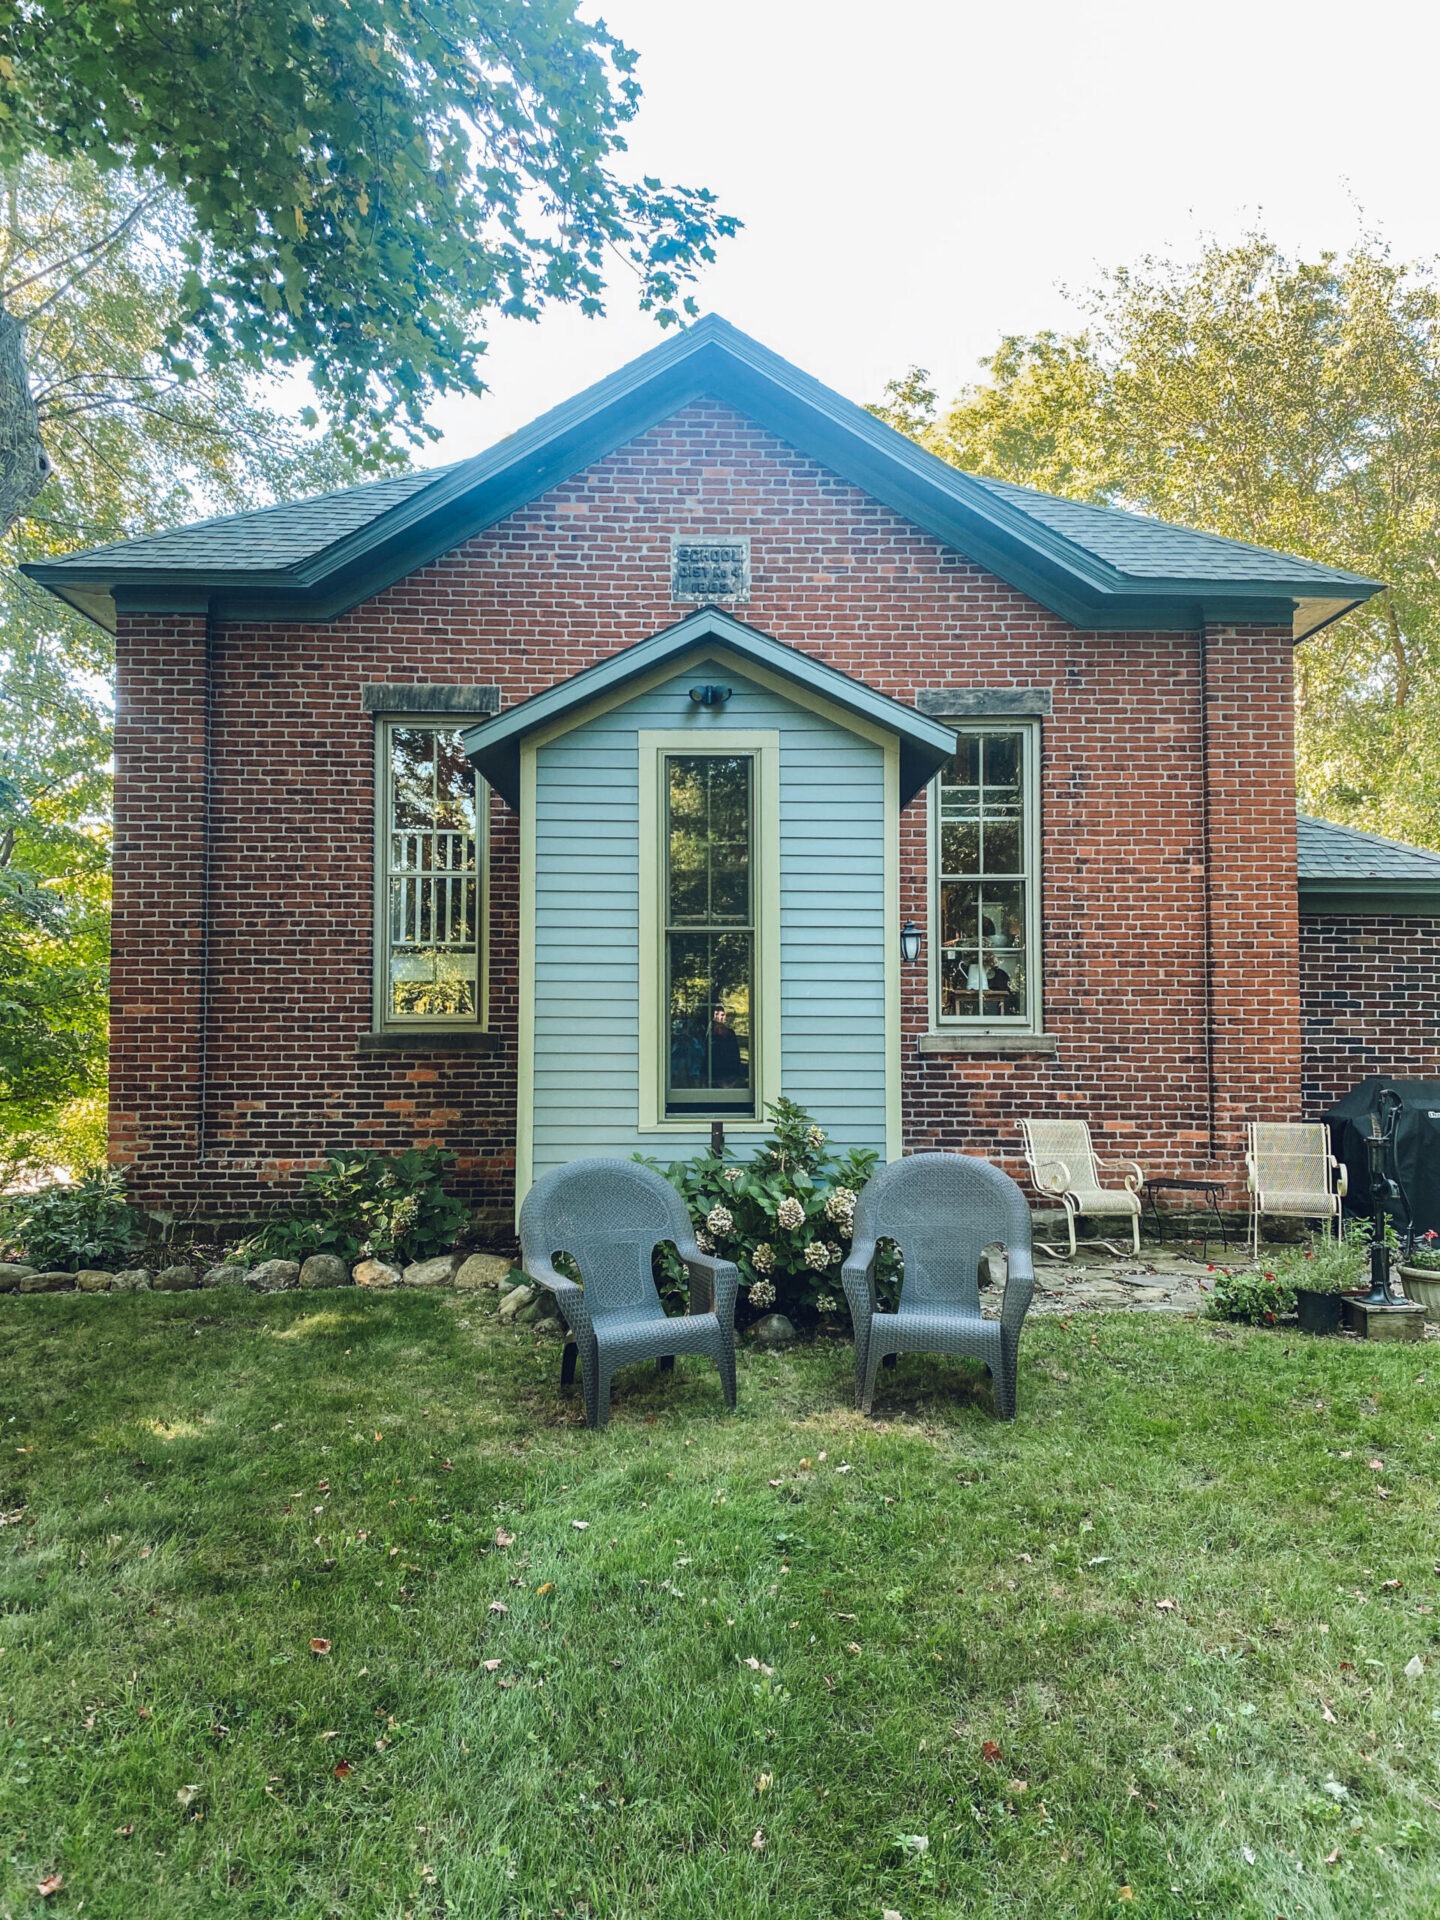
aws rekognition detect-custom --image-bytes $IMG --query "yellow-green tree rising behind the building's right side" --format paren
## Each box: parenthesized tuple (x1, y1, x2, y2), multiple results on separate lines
(876, 234, 1440, 847)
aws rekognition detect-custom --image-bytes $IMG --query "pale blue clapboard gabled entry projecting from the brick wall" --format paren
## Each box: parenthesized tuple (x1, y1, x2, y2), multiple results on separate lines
(465, 609, 954, 1198)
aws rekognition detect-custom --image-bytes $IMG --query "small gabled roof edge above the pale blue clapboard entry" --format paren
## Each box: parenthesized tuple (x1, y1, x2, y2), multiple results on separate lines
(463, 607, 954, 812)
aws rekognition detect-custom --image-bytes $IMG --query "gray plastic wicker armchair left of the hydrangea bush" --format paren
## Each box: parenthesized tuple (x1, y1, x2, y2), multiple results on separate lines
(520, 1160, 739, 1427)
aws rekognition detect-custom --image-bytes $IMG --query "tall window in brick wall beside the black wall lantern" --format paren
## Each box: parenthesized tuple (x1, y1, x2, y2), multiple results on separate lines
(931, 722, 1041, 1031)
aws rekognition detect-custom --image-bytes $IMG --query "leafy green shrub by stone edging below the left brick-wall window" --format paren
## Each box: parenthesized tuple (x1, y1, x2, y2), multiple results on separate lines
(230, 1146, 470, 1261)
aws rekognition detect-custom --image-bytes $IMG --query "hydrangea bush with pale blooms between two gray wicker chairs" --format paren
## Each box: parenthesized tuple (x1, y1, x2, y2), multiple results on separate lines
(639, 1100, 879, 1321)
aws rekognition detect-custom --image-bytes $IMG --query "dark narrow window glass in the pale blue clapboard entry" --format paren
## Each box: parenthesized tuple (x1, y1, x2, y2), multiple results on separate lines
(664, 753, 755, 1116)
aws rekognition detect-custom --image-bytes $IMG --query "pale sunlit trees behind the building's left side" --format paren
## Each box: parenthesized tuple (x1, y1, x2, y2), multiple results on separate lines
(0, 161, 384, 1187)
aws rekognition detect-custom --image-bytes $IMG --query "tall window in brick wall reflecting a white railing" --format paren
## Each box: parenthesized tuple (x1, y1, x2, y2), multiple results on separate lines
(376, 718, 486, 1031)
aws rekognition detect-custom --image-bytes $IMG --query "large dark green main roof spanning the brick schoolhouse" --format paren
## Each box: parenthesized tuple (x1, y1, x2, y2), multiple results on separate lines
(25, 315, 1379, 639)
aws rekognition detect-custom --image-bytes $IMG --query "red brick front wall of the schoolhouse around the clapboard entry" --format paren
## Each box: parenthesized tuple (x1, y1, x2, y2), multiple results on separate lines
(113, 403, 1300, 1215)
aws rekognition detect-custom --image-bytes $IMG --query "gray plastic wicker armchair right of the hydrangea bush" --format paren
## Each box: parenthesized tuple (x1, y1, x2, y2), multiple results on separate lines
(841, 1154, 1035, 1421)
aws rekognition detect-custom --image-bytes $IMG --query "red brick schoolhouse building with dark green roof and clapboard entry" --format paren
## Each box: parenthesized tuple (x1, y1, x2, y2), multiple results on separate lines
(29, 319, 1440, 1221)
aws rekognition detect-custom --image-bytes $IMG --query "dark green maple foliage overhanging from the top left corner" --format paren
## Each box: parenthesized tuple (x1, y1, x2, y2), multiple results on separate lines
(0, 0, 735, 526)
